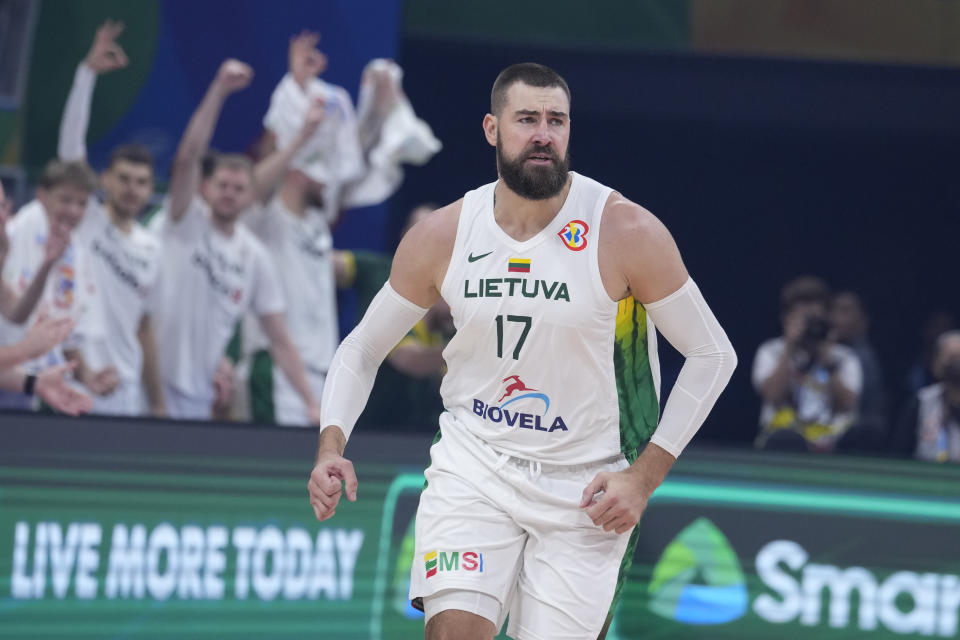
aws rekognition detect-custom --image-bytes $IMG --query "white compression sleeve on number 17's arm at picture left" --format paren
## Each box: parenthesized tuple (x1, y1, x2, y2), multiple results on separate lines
(320, 281, 427, 438)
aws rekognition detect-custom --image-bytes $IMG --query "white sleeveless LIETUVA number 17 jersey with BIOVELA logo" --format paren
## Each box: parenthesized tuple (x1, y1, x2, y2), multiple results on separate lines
(440, 172, 659, 464)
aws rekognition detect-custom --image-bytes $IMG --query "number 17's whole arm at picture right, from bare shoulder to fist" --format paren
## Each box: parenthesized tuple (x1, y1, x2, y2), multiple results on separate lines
(580, 194, 737, 534)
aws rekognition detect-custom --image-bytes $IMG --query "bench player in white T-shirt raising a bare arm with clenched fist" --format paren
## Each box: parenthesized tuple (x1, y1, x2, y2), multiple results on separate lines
(152, 60, 320, 424)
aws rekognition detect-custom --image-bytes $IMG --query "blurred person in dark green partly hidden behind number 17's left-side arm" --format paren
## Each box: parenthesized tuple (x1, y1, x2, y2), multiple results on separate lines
(335, 205, 454, 431)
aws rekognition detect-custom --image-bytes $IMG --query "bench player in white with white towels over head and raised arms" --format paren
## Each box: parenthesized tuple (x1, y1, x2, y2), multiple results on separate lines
(238, 32, 439, 425)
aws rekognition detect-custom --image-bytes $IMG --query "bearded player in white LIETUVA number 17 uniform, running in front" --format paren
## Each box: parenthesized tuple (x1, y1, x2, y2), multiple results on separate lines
(308, 64, 736, 640)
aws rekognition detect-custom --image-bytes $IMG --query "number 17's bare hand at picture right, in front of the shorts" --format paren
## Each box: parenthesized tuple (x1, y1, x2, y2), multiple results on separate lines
(580, 467, 652, 533)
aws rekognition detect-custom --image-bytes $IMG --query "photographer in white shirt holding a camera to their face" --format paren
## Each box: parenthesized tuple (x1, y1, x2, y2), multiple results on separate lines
(753, 276, 863, 451)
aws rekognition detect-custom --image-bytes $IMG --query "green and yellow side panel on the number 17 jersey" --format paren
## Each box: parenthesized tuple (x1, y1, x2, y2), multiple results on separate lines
(613, 298, 660, 463)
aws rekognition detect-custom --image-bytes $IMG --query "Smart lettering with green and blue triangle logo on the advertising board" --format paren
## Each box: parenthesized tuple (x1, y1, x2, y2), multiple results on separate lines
(648, 518, 960, 638)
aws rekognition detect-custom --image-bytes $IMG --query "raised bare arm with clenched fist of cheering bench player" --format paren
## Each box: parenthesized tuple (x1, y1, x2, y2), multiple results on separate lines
(167, 59, 253, 222)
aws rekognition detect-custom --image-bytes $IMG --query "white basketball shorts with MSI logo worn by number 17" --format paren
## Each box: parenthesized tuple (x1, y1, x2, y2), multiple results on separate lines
(410, 413, 630, 640)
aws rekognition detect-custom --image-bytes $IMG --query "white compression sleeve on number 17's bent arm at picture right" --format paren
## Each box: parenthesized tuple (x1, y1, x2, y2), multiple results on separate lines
(644, 278, 737, 457)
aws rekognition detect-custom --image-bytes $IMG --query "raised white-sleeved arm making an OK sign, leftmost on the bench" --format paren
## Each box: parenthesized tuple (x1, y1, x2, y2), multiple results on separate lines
(57, 20, 128, 162)
